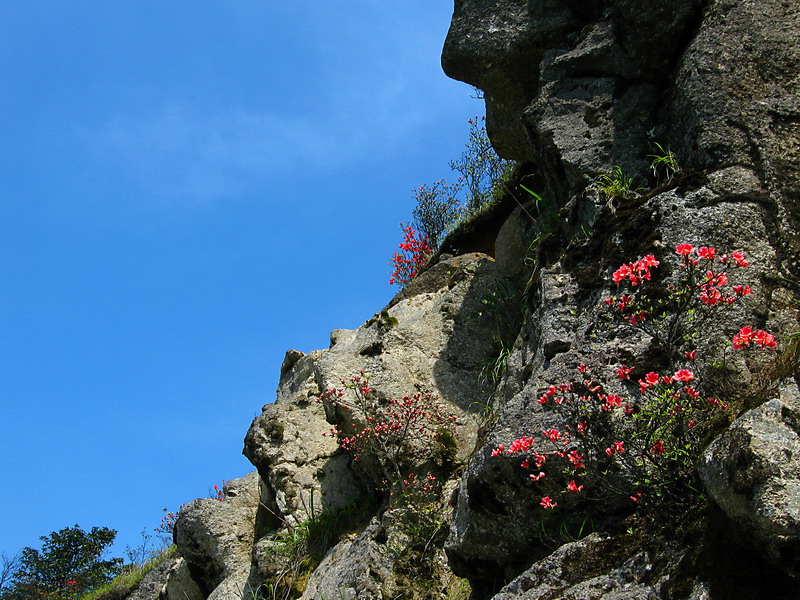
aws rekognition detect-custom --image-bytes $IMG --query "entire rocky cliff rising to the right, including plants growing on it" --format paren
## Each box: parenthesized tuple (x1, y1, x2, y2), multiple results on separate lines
(120, 0, 800, 600)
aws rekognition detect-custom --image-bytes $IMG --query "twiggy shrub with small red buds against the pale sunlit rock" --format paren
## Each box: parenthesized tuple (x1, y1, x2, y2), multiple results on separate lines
(318, 372, 456, 493)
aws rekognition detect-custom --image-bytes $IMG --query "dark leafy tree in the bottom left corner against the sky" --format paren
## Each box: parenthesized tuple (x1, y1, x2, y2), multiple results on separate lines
(2, 525, 122, 600)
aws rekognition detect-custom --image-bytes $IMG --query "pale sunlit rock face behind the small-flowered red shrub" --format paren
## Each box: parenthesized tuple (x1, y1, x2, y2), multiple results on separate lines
(244, 253, 520, 528)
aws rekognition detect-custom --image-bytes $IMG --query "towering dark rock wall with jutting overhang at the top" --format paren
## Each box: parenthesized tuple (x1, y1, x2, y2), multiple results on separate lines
(442, 0, 800, 597)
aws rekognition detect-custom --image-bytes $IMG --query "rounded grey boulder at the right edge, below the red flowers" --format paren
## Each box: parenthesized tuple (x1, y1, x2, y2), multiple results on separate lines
(700, 382, 800, 575)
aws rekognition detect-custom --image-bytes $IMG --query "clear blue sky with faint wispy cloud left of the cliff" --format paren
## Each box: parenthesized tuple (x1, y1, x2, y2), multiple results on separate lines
(0, 0, 483, 555)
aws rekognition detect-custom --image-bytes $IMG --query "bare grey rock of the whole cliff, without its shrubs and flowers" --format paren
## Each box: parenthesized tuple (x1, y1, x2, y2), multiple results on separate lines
(144, 0, 800, 600)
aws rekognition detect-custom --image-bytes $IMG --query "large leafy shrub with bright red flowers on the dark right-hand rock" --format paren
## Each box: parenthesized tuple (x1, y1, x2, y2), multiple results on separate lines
(492, 243, 777, 513)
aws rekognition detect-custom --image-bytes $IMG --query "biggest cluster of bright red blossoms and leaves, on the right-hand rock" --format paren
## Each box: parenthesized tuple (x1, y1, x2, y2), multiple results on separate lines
(492, 243, 777, 509)
